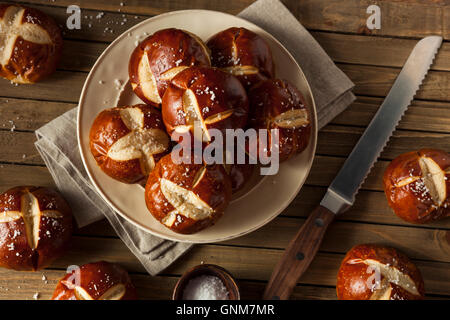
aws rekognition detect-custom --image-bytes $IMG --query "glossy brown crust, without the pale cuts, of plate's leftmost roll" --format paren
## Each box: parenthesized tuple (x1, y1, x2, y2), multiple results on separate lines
(89, 104, 170, 183)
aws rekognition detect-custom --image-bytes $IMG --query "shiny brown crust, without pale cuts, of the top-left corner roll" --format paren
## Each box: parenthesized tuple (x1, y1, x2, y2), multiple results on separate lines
(0, 4, 62, 83)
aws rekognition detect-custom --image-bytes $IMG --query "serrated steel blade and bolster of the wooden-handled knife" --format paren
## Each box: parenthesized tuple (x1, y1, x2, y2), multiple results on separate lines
(320, 36, 442, 213)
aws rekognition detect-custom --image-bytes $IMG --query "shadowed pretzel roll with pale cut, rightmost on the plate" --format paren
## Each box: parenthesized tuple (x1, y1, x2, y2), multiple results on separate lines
(248, 79, 312, 162)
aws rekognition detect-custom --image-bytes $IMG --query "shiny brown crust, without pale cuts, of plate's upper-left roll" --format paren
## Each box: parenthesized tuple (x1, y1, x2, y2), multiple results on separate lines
(128, 28, 211, 106)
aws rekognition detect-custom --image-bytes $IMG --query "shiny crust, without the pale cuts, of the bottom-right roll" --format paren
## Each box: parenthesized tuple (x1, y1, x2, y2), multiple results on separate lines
(336, 244, 425, 300)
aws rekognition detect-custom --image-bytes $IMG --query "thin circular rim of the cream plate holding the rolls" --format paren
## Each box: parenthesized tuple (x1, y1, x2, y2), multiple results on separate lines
(77, 9, 319, 244)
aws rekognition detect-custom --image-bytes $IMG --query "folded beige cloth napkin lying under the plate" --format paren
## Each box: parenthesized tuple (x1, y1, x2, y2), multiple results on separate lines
(35, 0, 354, 275)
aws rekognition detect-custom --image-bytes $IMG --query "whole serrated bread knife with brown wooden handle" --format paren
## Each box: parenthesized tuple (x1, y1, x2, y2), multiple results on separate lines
(263, 36, 442, 300)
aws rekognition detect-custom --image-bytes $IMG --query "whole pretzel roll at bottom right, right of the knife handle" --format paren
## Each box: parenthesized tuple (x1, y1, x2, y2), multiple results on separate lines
(336, 244, 425, 300)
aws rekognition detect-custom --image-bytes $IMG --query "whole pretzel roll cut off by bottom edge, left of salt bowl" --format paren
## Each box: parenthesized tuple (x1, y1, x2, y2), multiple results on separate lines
(52, 261, 137, 300)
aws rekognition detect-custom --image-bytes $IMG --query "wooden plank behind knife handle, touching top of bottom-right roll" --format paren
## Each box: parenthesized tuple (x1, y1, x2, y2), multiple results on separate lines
(223, 217, 450, 262)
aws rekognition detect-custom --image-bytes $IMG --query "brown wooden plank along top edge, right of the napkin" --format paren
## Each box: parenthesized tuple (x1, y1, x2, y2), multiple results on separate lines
(286, 0, 450, 39)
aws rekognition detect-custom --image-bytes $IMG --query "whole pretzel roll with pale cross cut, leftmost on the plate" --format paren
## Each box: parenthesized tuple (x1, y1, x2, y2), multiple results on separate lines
(90, 104, 170, 183)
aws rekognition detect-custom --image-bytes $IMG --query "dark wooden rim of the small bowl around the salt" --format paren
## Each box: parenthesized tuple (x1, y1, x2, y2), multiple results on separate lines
(172, 264, 241, 300)
